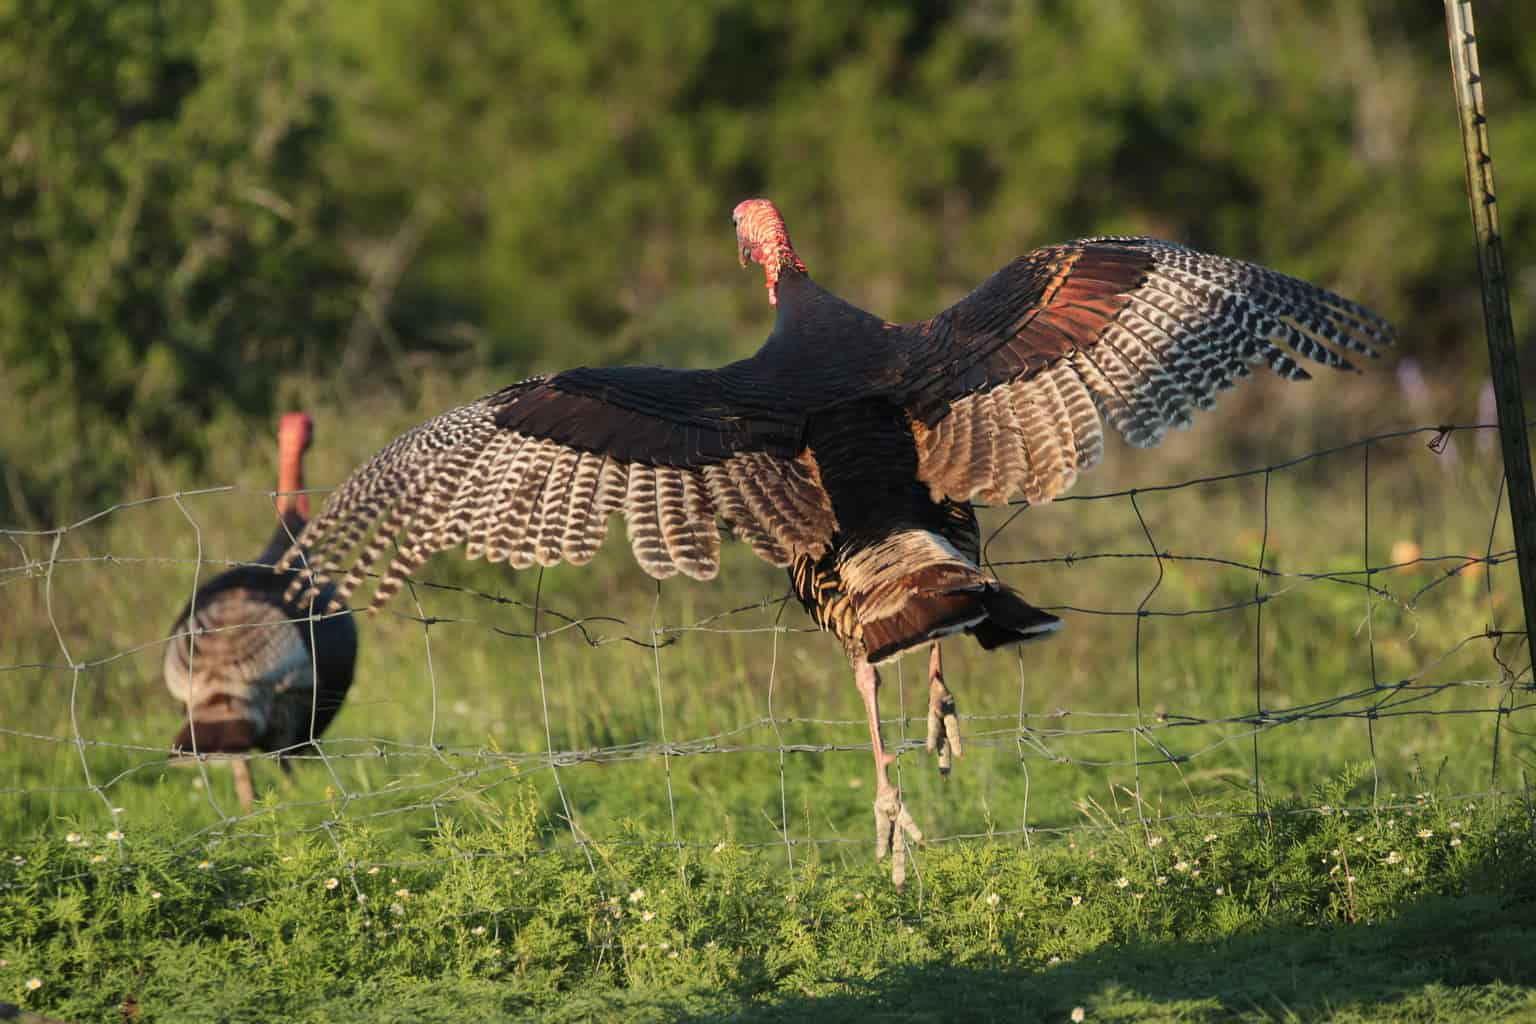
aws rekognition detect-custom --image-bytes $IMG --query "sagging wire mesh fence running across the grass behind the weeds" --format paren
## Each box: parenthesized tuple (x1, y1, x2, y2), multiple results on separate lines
(0, 424, 1536, 884)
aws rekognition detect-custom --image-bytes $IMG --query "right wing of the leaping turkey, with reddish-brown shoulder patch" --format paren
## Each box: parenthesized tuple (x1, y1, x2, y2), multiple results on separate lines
(903, 238, 1392, 504)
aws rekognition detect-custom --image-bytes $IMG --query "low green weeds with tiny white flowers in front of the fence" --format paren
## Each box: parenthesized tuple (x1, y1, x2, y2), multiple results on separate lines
(0, 777, 1536, 1021)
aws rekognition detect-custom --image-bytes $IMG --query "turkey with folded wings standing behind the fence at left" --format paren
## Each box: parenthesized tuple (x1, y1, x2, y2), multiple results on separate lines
(163, 413, 358, 811)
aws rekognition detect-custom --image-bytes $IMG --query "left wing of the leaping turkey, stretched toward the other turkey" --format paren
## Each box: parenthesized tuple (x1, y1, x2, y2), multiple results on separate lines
(283, 367, 836, 606)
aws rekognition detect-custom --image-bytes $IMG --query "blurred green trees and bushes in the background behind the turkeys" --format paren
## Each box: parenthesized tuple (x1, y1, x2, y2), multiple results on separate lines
(0, 0, 1536, 522)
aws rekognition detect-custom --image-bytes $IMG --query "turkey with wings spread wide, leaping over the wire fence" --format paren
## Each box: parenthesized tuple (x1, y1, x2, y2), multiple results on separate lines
(284, 200, 1392, 884)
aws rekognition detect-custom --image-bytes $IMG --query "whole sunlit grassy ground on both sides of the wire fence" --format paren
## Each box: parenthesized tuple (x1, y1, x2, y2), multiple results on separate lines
(0, 381, 1536, 1021)
